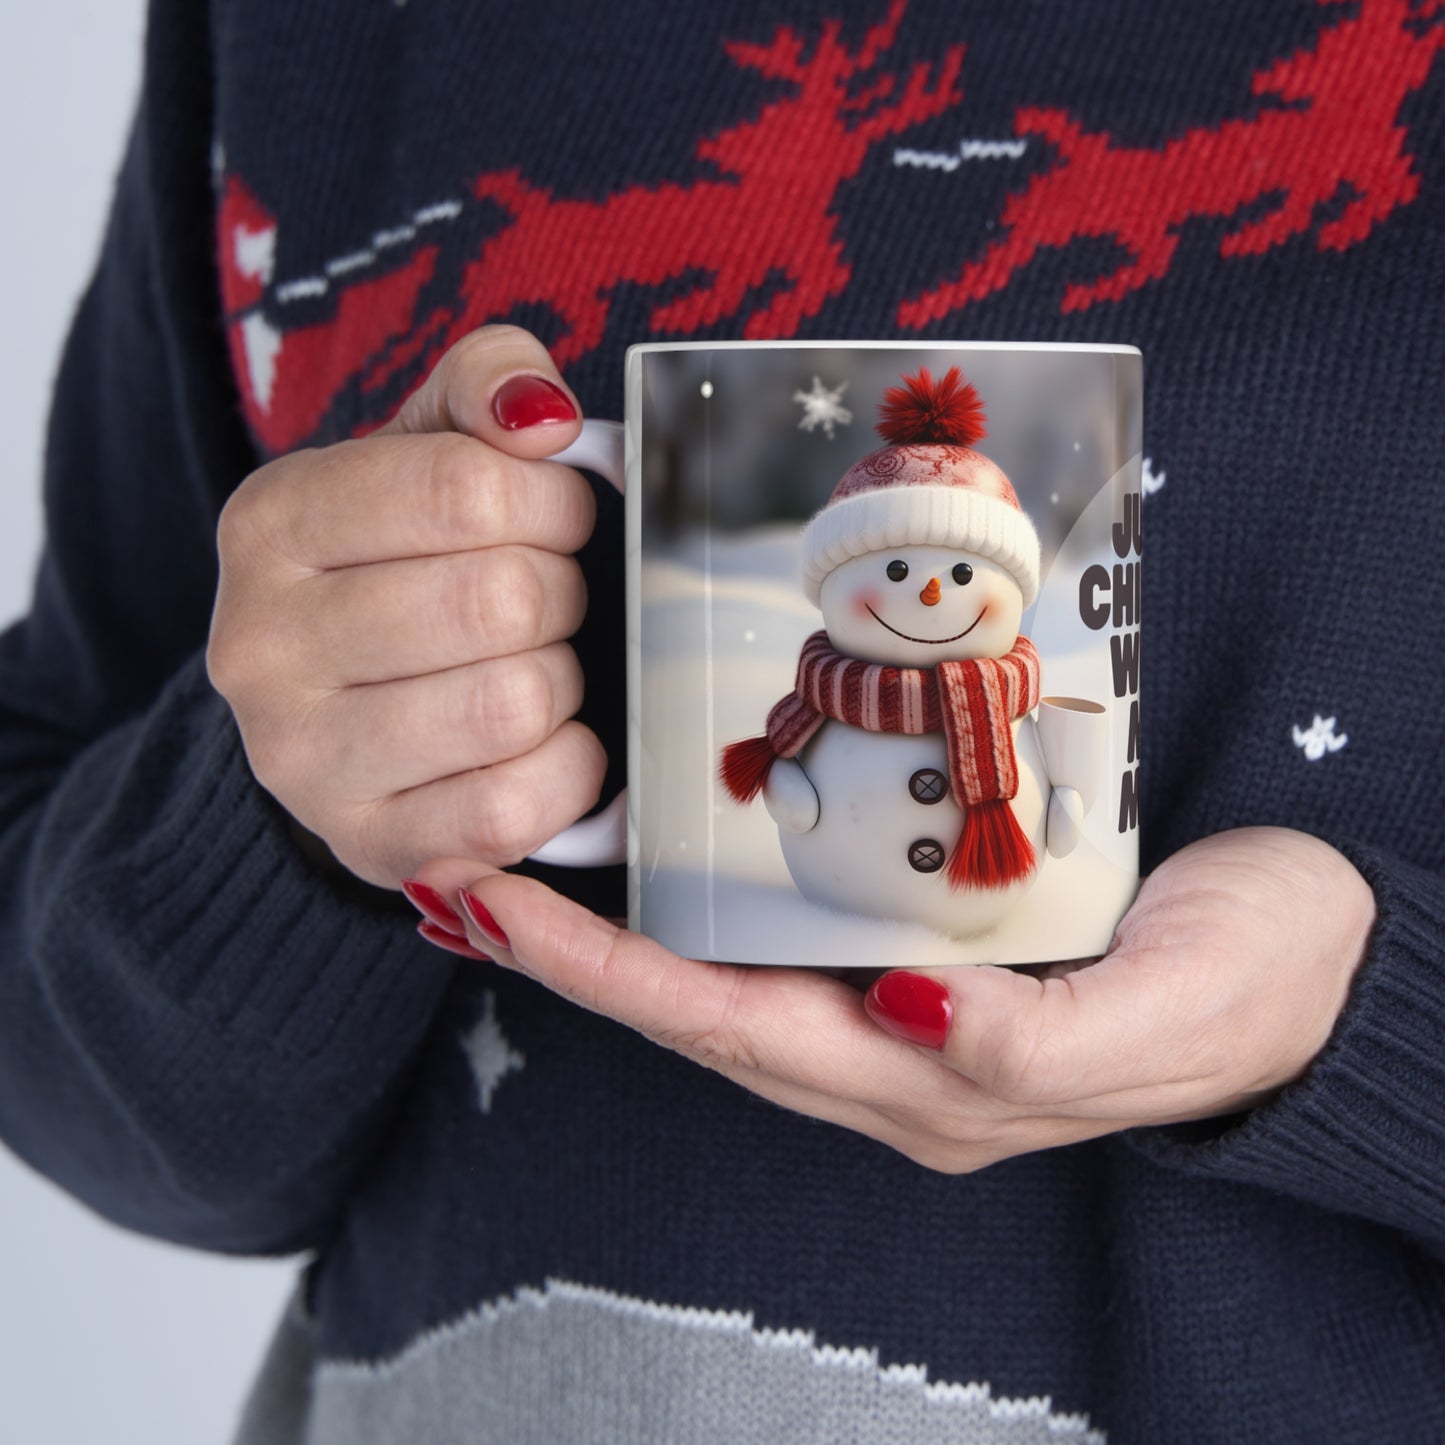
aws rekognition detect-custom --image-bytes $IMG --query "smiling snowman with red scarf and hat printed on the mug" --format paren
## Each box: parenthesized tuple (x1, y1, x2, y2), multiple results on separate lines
(721, 367, 1084, 938)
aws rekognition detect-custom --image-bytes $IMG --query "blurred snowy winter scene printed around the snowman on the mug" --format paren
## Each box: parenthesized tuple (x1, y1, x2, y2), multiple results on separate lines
(634, 345, 1140, 965)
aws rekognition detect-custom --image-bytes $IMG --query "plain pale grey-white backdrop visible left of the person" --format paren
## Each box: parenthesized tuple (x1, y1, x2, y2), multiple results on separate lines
(0, 0, 295, 1445)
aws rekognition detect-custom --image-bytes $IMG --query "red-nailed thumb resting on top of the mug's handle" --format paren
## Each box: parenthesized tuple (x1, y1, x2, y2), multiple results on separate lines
(381, 327, 582, 460)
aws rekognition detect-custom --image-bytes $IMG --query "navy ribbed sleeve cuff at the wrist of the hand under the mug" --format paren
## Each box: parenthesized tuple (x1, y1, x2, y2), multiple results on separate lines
(1131, 845, 1445, 1256)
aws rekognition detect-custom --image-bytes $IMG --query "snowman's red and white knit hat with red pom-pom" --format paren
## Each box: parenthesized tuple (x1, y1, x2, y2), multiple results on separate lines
(803, 367, 1039, 607)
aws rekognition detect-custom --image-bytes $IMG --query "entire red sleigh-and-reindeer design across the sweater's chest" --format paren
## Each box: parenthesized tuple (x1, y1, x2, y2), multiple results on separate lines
(218, 0, 1445, 451)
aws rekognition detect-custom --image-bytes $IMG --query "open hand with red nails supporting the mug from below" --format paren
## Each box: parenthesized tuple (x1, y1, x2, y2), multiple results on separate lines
(410, 828, 1374, 1172)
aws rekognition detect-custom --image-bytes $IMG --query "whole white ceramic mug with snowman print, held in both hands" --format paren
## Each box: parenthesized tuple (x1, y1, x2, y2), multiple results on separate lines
(543, 342, 1142, 968)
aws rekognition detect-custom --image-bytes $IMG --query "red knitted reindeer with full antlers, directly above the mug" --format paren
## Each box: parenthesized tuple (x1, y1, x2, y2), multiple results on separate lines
(401, 0, 964, 366)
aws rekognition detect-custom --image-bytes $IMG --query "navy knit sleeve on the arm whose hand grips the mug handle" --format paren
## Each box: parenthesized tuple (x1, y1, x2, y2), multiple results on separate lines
(0, 3, 449, 1251)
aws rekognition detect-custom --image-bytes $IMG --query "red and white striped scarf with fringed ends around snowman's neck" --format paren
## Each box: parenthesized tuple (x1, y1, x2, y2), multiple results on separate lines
(721, 631, 1039, 889)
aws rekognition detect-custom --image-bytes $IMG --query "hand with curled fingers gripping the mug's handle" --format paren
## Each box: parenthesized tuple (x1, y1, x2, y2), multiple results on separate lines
(207, 327, 605, 887)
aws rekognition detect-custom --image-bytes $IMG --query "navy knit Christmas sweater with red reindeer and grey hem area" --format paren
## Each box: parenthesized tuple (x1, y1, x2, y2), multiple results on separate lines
(0, 0, 1445, 1445)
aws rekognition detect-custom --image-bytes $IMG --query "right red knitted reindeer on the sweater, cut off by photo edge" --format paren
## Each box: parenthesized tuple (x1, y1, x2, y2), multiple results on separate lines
(897, 0, 1445, 328)
